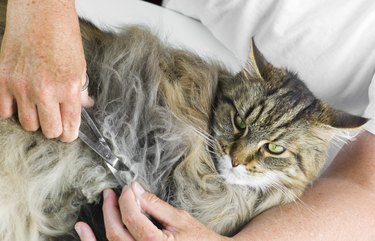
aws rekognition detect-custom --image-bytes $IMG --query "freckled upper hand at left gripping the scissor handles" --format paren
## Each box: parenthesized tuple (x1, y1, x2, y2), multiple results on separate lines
(0, 0, 92, 142)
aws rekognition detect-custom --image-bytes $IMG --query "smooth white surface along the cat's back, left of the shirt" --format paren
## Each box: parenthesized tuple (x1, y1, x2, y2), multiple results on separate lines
(76, 0, 239, 70)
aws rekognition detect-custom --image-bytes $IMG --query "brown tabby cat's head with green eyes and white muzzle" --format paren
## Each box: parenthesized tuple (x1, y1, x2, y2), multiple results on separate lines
(211, 40, 366, 189)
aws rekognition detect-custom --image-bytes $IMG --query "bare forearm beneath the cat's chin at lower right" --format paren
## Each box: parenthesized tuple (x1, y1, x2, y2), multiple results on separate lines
(234, 132, 375, 241)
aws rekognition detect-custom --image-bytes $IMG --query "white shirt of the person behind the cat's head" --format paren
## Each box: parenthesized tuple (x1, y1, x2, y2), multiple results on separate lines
(163, 0, 375, 134)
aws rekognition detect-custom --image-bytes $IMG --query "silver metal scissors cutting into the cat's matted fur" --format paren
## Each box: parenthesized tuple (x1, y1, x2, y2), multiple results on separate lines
(78, 108, 129, 187)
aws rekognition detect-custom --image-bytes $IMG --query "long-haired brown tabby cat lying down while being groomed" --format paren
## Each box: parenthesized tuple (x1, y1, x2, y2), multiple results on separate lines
(0, 1, 366, 241)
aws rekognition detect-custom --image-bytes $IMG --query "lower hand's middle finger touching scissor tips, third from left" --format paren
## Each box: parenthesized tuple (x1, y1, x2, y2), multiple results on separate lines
(119, 186, 163, 241)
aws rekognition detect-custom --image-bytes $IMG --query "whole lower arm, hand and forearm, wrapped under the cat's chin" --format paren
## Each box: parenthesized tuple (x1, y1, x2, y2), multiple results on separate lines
(76, 132, 375, 241)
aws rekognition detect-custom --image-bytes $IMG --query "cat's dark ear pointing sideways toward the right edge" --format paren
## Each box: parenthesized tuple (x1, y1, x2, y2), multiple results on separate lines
(320, 104, 368, 130)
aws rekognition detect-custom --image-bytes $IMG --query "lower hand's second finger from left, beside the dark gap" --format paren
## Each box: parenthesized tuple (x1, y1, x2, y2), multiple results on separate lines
(103, 189, 134, 241)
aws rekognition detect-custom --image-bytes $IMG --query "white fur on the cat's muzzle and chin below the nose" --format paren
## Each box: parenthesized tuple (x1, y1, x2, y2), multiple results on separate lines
(217, 155, 277, 189)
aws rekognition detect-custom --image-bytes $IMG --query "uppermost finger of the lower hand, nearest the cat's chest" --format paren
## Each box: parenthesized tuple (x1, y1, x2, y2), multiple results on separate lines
(132, 183, 187, 227)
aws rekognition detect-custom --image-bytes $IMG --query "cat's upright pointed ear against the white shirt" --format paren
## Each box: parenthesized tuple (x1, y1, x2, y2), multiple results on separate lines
(242, 37, 286, 81)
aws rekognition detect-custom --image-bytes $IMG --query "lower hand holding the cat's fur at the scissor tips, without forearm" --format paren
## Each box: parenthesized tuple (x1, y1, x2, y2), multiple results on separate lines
(75, 183, 231, 241)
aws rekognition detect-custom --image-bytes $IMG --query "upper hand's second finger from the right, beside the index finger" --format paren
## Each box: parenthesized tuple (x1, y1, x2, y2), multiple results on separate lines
(37, 102, 62, 139)
